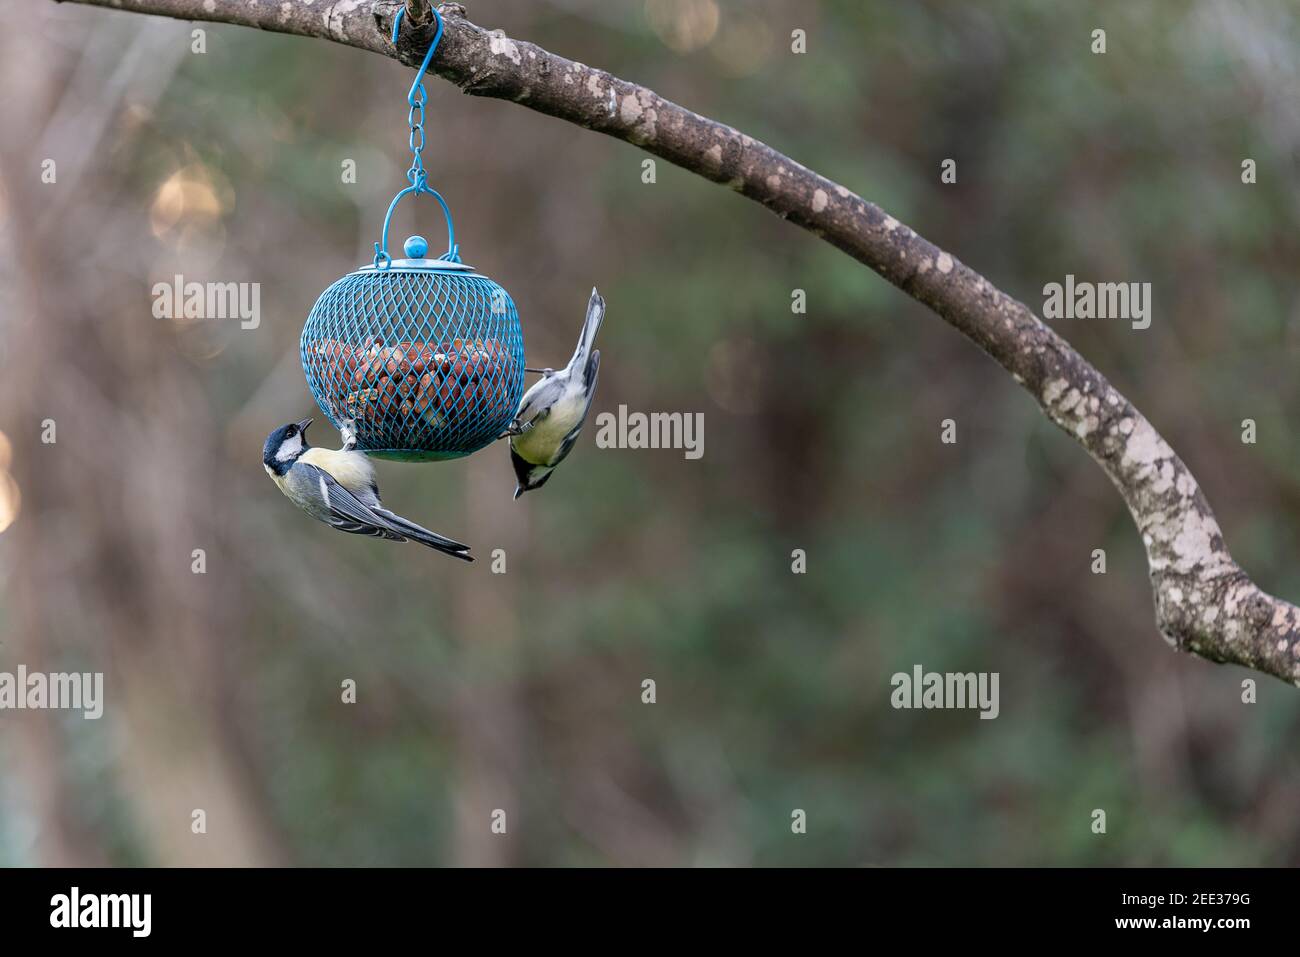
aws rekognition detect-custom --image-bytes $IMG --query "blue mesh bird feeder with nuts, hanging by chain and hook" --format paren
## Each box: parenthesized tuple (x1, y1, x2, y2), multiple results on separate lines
(300, 8, 524, 462)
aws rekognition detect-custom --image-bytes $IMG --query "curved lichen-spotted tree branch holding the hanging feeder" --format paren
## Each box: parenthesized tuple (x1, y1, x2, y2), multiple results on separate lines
(50, 0, 1300, 685)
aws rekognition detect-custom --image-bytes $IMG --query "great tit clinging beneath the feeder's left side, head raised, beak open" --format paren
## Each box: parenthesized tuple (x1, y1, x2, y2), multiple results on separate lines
(261, 419, 475, 562)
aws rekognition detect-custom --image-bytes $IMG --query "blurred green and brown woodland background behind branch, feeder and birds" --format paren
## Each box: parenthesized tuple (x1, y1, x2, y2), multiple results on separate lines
(0, 0, 1300, 865)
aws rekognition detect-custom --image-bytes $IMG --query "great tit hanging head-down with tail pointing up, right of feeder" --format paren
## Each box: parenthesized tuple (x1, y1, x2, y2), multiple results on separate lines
(506, 289, 605, 498)
